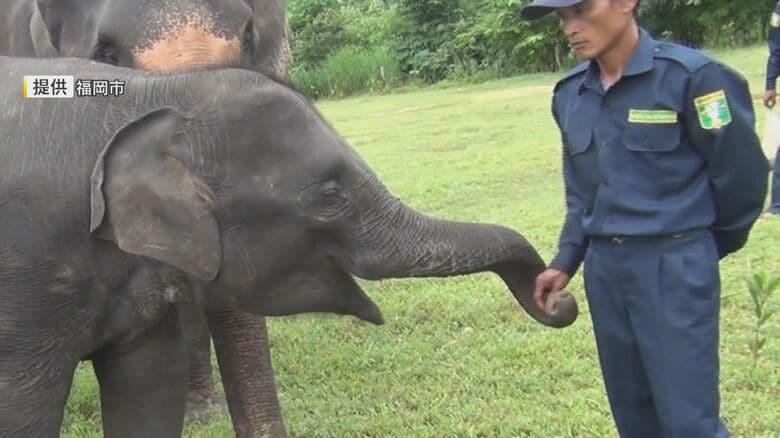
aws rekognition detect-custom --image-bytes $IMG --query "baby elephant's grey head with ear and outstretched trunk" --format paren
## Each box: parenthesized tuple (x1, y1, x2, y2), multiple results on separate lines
(87, 70, 577, 327)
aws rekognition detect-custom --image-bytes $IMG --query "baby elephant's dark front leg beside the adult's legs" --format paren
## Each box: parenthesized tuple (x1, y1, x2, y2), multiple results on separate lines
(92, 307, 188, 438)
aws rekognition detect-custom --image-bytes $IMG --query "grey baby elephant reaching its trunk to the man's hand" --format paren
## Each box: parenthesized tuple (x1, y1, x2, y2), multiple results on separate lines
(0, 57, 577, 438)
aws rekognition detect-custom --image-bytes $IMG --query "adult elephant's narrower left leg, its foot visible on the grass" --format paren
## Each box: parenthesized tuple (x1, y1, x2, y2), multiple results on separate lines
(183, 306, 227, 421)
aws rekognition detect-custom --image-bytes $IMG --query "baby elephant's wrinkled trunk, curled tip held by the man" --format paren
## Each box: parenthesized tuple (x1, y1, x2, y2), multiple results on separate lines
(349, 173, 578, 328)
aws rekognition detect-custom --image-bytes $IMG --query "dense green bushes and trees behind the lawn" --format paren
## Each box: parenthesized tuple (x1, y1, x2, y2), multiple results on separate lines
(288, 0, 776, 98)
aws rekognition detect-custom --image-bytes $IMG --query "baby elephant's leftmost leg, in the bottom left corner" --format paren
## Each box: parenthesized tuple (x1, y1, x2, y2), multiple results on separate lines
(0, 358, 78, 438)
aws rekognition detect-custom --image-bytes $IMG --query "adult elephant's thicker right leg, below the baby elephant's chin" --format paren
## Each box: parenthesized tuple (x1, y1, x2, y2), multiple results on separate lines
(209, 310, 287, 438)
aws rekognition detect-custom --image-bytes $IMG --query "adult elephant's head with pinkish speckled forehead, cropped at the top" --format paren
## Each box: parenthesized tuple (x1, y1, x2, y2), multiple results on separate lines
(30, 0, 290, 75)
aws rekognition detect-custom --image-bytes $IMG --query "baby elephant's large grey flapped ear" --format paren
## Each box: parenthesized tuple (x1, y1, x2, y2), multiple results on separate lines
(90, 107, 222, 281)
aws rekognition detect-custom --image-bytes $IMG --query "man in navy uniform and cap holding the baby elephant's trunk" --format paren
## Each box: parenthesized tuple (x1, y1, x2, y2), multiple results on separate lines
(522, 0, 769, 438)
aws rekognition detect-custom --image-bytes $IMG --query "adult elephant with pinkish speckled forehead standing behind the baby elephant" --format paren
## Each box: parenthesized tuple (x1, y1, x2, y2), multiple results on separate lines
(0, 0, 292, 437)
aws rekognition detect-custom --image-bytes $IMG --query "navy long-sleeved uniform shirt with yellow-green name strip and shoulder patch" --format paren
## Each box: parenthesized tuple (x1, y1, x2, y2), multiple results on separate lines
(550, 29, 769, 275)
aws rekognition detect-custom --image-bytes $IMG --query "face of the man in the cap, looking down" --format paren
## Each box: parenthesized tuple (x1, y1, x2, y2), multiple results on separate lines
(556, 0, 636, 60)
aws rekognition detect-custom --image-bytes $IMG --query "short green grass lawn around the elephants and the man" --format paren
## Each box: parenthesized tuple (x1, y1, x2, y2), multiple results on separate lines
(64, 46, 780, 437)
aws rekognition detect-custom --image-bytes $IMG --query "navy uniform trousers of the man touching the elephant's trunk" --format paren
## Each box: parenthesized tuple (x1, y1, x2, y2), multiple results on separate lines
(583, 229, 730, 438)
